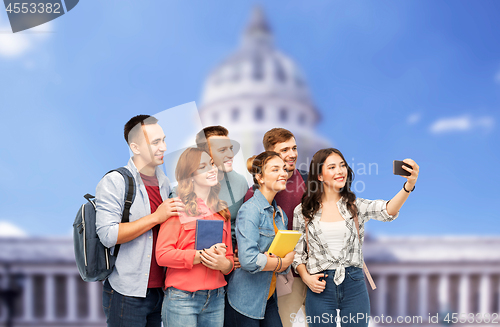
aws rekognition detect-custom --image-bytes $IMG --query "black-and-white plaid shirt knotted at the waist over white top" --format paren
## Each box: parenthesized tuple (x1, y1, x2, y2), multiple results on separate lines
(292, 198, 399, 285)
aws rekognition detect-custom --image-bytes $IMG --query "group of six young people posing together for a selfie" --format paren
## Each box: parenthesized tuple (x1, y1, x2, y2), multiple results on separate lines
(96, 115, 419, 327)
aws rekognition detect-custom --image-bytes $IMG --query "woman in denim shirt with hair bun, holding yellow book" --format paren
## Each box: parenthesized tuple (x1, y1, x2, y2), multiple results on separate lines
(227, 151, 295, 327)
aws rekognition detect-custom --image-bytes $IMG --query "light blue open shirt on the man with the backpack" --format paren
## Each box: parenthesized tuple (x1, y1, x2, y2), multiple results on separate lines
(95, 158, 170, 297)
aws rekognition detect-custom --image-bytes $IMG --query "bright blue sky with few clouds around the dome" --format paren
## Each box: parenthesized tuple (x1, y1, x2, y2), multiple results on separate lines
(0, 0, 500, 236)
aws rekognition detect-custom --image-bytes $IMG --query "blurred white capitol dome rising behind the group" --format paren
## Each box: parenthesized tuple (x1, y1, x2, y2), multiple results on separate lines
(200, 8, 328, 169)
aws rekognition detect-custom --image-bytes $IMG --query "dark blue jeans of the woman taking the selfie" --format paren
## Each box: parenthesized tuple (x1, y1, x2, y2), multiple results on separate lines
(306, 267, 370, 327)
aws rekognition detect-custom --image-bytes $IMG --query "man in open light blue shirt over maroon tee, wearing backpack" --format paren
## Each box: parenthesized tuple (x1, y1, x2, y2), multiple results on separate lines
(96, 115, 184, 327)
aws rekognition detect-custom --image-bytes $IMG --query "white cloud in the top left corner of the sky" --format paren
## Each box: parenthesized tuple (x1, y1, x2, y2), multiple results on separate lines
(0, 15, 53, 59)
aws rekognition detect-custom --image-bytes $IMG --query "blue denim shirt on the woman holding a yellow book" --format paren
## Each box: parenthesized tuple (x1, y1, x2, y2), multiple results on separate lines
(227, 189, 290, 319)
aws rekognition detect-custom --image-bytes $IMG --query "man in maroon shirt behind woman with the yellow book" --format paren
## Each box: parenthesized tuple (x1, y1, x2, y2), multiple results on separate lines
(245, 128, 307, 327)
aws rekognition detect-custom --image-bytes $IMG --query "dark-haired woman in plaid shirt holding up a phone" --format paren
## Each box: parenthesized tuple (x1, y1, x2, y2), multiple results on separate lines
(293, 148, 419, 327)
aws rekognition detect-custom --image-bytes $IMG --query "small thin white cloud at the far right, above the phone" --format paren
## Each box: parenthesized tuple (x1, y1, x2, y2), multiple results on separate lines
(430, 115, 495, 134)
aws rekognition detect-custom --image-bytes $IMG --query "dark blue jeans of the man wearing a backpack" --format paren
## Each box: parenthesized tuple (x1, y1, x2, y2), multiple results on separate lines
(102, 279, 163, 327)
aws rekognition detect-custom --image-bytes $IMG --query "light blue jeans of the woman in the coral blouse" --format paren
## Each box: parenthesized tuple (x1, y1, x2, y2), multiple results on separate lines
(161, 287, 226, 327)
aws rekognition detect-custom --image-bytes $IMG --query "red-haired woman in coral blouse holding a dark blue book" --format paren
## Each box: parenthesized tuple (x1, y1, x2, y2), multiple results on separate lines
(156, 148, 233, 327)
